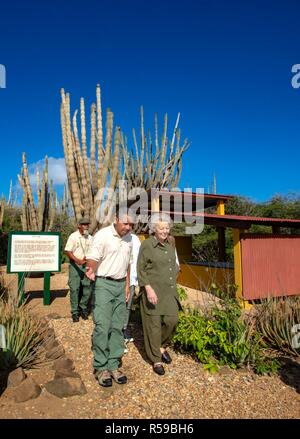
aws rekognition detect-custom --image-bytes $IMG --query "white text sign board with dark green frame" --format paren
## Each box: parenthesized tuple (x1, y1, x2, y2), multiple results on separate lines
(7, 232, 60, 273)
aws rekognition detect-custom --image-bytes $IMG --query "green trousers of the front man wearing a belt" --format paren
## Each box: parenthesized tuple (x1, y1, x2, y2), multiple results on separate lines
(93, 277, 126, 371)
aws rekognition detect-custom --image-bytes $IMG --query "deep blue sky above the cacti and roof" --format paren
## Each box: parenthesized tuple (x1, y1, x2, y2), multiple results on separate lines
(0, 0, 300, 201)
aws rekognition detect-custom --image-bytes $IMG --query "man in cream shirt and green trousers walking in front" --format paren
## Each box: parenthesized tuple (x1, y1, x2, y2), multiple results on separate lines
(86, 212, 132, 387)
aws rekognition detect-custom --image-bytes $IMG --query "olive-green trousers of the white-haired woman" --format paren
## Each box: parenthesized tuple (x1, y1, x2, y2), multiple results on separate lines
(140, 300, 178, 363)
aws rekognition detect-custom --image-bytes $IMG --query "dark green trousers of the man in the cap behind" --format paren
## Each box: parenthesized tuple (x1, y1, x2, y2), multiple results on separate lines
(68, 263, 92, 315)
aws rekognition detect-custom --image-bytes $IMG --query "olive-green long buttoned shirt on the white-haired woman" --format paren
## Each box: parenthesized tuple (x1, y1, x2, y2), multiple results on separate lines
(137, 236, 180, 315)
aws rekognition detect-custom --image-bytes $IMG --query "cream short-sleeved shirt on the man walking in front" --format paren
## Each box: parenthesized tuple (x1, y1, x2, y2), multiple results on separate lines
(87, 224, 132, 279)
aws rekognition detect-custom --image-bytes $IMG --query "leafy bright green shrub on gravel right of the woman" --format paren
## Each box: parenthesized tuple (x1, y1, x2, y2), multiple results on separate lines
(173, 299, 276, 373)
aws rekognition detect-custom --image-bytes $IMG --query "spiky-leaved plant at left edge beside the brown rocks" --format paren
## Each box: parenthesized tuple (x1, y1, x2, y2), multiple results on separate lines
(0, 295, 45, 371)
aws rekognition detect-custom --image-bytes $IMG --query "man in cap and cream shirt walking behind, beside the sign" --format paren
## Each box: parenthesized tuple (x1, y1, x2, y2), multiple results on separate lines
(65, 218, 93, 322)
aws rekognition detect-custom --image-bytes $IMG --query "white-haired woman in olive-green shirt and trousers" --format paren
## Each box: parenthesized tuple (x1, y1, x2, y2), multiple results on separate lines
(137, 213, 180, 375)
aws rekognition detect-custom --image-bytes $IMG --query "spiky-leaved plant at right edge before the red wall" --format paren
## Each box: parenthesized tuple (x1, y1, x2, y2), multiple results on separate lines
(256, 296, 300, 357)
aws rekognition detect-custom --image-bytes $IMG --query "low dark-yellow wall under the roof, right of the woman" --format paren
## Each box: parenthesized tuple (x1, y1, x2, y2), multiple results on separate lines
(177, 263, 234, 291)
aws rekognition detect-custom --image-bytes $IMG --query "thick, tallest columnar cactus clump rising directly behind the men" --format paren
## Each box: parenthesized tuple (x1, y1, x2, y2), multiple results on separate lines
(61, 85, 120, 230)
